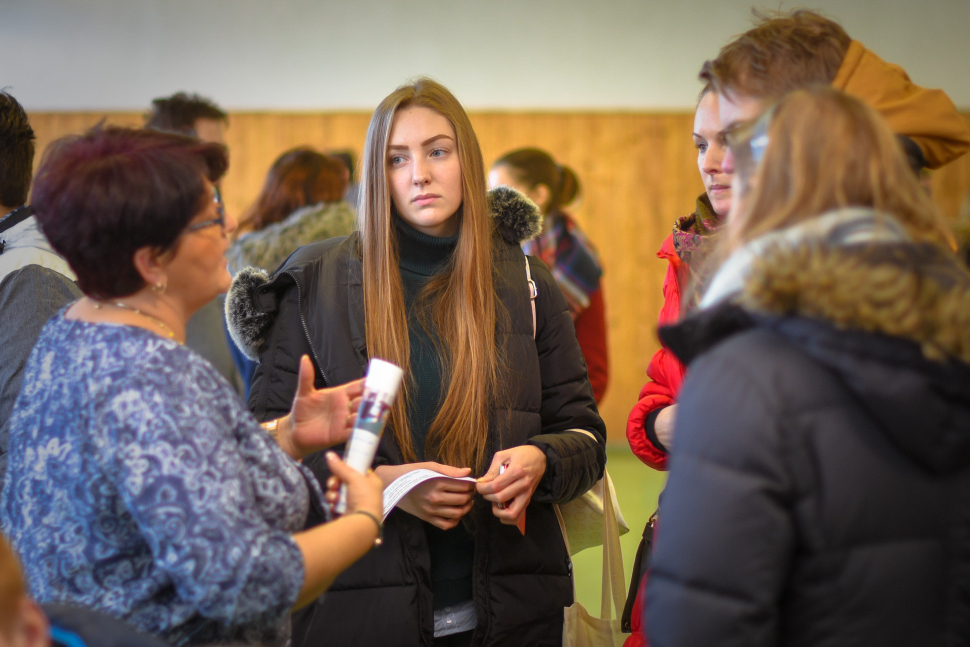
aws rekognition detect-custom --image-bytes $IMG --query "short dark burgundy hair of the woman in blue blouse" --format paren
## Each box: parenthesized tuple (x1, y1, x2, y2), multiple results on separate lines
(32, 126, 229, 299)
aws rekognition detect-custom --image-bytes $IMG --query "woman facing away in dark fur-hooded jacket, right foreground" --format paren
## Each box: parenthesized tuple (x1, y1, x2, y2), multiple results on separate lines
(644, 86, 970, 647)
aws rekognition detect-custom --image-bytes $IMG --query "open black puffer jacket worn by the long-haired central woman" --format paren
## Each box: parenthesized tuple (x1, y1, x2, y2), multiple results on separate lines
(228, 190, 606, 647)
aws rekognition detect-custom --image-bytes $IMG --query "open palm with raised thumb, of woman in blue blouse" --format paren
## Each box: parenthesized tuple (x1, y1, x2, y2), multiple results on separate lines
(288, 355, 364, 459)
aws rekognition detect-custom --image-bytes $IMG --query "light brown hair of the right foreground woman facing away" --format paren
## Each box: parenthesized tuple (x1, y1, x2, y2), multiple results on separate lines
(728, 86, 953, 250)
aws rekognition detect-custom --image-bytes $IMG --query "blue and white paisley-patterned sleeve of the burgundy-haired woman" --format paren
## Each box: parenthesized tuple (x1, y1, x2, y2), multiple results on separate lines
(95, 349, 304, 625)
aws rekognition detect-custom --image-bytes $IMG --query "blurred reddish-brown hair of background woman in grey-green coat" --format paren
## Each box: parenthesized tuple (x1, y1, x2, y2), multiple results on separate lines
(242, 146, 348, 231)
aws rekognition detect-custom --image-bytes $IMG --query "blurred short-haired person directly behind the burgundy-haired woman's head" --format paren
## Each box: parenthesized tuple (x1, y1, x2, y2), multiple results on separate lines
(145, 92, 245, 393)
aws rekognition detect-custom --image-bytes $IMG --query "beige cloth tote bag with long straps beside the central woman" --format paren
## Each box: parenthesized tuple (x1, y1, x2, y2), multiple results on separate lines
(556, 470, 626, 647)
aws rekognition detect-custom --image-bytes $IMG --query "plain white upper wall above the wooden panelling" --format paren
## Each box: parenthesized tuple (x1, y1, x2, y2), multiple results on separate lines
(0, 0, 970, 110)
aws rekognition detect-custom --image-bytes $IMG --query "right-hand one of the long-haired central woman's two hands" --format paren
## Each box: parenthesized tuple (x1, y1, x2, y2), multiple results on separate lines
(477, 445, 546, 526)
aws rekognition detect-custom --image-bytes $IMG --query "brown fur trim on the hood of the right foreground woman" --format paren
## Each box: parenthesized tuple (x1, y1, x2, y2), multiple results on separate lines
(737, 225, 970, 363)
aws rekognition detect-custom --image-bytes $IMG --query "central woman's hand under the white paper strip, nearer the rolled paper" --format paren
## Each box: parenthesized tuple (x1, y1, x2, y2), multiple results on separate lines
(375, 461, 475, 530)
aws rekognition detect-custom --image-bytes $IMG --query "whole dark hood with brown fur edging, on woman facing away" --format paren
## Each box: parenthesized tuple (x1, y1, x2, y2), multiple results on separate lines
(661, 212, 970, 472)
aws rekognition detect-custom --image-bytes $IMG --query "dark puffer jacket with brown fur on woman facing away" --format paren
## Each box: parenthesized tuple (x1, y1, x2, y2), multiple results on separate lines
(645, 235, 970, 647)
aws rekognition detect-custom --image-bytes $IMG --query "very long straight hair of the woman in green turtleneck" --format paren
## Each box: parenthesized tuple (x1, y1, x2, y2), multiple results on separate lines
(358, 78, 500, 471)
